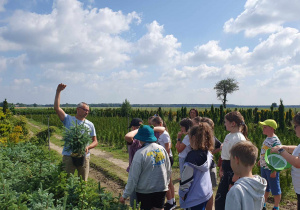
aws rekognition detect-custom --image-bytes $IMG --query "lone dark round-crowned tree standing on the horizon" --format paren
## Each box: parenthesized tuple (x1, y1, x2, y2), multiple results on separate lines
(214, 78, 239, 108)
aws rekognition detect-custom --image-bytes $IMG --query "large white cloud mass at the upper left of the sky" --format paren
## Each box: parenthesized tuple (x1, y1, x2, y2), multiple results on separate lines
(0, 0, 141, 71)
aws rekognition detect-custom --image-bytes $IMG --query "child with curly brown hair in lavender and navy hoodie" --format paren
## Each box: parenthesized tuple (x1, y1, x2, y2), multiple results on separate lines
(179, 122, 214, 210)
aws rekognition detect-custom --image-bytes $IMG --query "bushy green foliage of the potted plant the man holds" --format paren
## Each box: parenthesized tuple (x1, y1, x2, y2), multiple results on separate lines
(62, 122, 92, 155)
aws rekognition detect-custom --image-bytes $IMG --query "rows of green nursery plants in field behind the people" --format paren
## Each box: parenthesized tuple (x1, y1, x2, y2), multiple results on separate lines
(20, 107, 299, 199)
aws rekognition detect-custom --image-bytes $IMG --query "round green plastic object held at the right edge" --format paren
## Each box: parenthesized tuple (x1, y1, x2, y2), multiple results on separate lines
(265, 149, 292, 172)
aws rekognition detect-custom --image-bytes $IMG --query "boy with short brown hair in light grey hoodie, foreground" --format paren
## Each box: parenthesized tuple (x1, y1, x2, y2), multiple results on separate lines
(225, 141, 267, 210)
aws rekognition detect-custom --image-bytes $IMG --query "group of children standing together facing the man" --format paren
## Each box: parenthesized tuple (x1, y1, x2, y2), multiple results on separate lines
(120, 109, 300, 210)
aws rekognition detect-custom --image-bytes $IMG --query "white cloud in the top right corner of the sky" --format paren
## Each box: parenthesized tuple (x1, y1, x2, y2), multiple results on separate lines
(224, 0, 300, 36)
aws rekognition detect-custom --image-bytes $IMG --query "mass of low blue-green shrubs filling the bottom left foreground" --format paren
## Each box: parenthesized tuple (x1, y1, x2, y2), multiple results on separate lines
(0, 142, 128, 210)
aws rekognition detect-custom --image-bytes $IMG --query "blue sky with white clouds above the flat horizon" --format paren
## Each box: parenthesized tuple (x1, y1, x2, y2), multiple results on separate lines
(0, 0, 300, 105)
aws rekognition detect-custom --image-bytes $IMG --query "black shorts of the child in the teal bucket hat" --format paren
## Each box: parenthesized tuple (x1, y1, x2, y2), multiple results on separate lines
(136, 191, 167, 210)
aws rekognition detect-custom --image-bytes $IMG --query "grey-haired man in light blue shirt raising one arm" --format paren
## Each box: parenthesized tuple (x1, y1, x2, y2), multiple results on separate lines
(54, 83, 98, 181)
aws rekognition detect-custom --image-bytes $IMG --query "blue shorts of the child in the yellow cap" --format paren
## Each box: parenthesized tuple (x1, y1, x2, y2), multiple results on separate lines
(260, 168, 281, 195)
